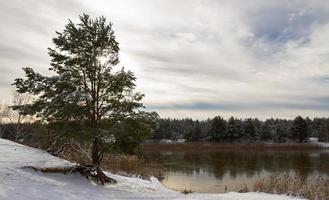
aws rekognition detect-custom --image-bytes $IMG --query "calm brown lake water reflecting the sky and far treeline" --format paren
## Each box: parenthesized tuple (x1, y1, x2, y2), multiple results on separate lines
(145, 149, 329, 193)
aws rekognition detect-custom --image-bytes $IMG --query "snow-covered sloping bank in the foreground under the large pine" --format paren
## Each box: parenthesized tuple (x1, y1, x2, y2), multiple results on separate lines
(0, 139, 297, 200)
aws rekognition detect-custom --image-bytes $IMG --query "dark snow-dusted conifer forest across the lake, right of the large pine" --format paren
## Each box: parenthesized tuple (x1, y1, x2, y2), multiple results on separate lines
(150, 116, 329, 143)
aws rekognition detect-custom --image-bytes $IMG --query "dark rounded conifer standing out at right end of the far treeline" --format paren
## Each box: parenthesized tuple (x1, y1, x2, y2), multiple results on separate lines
(290, 116, 308, 142)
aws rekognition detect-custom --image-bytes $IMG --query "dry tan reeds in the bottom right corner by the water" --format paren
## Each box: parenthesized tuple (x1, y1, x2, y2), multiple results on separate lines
(247, 174, 329, 200)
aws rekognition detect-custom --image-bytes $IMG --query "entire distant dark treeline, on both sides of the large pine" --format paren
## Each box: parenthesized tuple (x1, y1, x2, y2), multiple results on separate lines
(0, 116, 329, 145)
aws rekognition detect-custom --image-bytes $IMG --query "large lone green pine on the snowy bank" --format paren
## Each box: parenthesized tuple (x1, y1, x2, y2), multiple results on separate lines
(13, 14, 157, 166)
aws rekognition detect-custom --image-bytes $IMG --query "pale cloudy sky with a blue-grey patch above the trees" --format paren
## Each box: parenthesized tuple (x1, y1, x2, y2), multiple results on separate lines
(0, 0, 329, 119)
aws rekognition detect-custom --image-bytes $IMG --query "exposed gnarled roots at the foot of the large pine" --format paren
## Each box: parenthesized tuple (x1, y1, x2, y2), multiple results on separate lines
(23, 164, 117, 185)
